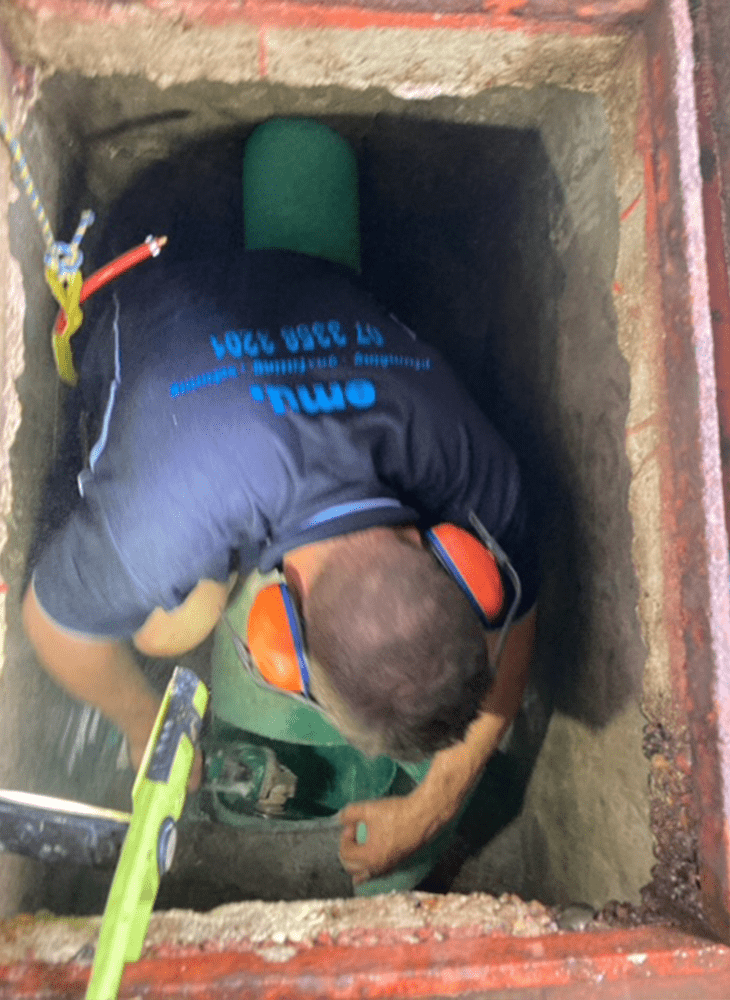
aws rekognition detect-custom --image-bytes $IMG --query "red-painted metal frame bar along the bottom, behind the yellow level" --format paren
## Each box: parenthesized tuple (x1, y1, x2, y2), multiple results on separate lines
(0, 927, 730, 1000)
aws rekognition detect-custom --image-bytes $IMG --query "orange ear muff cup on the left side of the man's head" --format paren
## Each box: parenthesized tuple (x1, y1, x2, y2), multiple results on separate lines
(248, 583, 309, 696)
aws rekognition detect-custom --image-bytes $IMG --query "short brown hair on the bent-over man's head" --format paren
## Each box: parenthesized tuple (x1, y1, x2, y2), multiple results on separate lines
(307, 531, 490, 760)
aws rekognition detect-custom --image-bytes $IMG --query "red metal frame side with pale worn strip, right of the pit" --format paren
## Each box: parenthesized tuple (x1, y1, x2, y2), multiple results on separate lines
(645, 0, 730, 940)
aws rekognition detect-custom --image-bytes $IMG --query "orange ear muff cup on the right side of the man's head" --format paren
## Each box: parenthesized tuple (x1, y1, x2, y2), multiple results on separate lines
(426, 524, 504, 627)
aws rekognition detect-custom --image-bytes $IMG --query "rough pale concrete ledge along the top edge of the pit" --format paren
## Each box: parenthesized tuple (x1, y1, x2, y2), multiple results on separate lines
(0, 0, 626, 98)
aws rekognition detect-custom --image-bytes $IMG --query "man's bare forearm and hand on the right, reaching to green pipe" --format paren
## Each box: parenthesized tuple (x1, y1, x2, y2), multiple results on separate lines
(340, 610, 536, 885)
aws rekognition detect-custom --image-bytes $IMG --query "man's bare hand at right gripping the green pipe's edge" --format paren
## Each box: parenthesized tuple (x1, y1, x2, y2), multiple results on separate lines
(340, 795, 438, 885)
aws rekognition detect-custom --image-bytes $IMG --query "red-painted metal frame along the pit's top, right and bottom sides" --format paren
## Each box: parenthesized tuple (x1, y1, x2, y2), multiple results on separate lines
(0, 0, 730, 1000)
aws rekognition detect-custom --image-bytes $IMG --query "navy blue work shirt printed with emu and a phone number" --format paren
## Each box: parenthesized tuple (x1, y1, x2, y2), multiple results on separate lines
(34, 251, 535, 638)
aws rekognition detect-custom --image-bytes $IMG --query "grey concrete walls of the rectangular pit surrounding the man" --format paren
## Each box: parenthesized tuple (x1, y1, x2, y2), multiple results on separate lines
(0, 8, 673, 928)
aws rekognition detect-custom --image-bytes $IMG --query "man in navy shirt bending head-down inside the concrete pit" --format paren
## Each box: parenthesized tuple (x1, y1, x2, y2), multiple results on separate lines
(23, 119, 537, 885)
